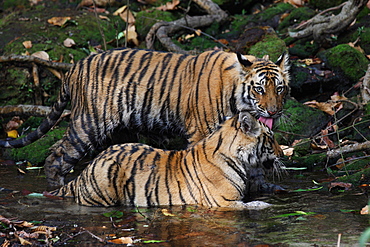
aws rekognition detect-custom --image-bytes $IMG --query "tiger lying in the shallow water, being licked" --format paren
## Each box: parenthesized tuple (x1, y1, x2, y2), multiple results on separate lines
(51, 112, 282, 208)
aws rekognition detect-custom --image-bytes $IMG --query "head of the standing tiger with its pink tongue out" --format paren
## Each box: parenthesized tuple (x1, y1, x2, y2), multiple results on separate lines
(235, 53, 290, 128)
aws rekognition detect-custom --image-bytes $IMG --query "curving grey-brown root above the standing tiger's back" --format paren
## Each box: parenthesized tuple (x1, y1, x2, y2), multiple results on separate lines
(146, 0, 228, 54)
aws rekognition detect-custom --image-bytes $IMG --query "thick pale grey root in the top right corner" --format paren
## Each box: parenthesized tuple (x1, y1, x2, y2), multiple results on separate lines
(289, 0, 368, 43)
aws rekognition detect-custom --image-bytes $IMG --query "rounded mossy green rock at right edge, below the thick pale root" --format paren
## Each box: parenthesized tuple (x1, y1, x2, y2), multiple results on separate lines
(320, 44, 369, 83)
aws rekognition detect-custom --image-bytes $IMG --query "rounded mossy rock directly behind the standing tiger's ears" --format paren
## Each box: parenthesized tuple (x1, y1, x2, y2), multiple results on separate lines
(249, 35, 286, 61)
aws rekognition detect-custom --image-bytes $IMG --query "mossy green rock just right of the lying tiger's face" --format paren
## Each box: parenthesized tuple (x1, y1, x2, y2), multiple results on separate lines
(275, 99, 330, 145)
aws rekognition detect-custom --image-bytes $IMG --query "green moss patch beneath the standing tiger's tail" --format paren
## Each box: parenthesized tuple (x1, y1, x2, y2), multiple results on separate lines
(7, 128, 66, 164)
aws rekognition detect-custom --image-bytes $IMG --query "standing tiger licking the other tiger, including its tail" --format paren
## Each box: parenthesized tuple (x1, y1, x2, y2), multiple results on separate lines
(0, 48, 289, 187)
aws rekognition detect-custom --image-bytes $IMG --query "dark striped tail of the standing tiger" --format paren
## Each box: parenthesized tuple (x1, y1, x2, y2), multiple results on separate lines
(0, 80, 69, 148)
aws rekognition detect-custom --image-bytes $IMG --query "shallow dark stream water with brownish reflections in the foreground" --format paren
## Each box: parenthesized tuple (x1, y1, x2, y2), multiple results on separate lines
(0, 162, 369, 246)
